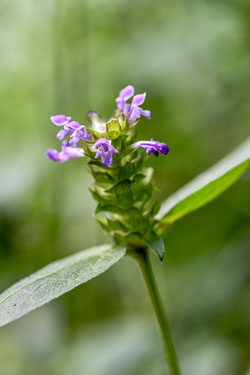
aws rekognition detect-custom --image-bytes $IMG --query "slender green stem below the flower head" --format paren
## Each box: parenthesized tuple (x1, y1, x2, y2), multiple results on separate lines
(136, 249, 181, 375)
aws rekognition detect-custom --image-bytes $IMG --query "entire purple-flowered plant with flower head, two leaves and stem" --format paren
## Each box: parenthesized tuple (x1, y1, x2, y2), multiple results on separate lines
(0, 86, 250, 375)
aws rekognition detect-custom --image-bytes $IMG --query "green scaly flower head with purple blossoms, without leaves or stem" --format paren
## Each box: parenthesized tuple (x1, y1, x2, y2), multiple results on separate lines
(47, 86, 169, 260)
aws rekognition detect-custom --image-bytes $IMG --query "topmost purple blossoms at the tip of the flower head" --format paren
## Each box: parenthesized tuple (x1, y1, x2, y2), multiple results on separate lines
(116, 85, 151, 124)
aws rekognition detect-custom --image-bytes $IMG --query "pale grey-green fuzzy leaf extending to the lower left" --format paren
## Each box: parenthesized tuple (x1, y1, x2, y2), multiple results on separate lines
(0, 245, 125, 326)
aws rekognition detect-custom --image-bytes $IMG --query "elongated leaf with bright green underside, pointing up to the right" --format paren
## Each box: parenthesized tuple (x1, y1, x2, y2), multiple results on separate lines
(156, 138, 250, 233)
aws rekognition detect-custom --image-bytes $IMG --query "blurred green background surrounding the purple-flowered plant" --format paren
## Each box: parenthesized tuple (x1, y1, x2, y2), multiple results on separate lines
(0, 0, 250, 375)
